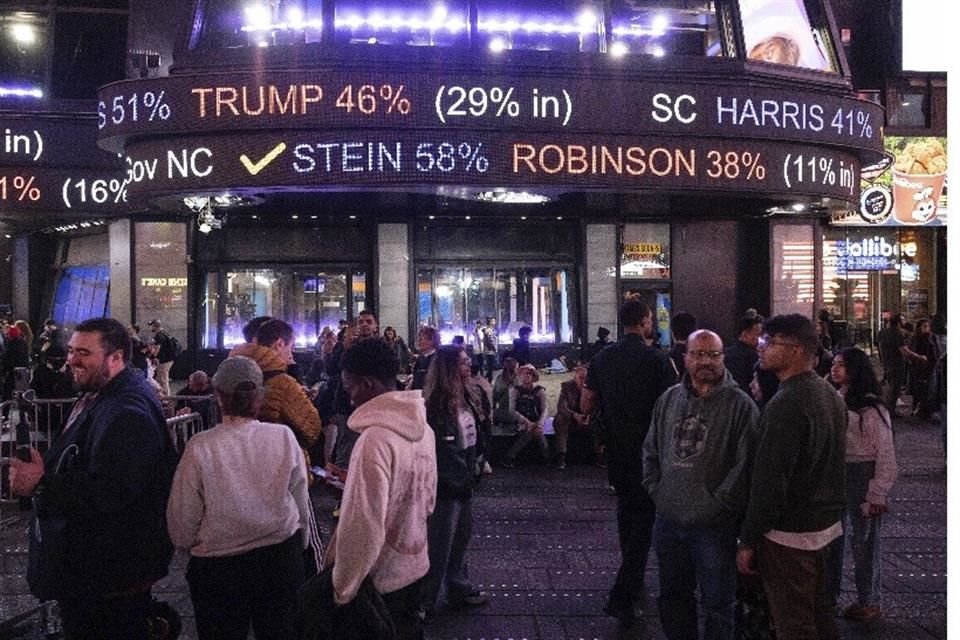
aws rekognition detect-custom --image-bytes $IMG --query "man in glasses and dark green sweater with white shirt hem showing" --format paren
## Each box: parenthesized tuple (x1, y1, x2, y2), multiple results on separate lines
(737, 314, 847, 640)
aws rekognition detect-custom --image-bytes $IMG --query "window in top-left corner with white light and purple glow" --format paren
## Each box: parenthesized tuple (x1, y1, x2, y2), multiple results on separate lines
(0, 11, 48, 98)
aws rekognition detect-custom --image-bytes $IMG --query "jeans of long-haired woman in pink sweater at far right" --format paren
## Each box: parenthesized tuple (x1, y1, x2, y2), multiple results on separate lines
(828, 462, 883, 607)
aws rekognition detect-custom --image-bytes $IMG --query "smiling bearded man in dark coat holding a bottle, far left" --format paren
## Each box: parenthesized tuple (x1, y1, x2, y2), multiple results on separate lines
(10, 318, 177, 640)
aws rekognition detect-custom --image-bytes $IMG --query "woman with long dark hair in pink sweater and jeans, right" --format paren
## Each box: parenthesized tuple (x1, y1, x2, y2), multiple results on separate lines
(828, 347, 897, 622)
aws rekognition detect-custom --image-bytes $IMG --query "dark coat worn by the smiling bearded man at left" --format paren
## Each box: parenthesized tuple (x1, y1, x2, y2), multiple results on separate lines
(27, 367, 178, 600)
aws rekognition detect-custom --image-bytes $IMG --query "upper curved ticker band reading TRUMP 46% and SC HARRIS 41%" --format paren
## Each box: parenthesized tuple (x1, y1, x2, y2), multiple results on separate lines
(97, 70, 883, 156)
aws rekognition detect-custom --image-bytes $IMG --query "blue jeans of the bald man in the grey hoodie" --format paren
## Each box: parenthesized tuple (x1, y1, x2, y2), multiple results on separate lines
(653, 514, 737, 640)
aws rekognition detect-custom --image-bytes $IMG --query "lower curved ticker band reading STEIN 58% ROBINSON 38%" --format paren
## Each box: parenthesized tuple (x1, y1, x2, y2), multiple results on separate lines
(126, 130, 860, 200)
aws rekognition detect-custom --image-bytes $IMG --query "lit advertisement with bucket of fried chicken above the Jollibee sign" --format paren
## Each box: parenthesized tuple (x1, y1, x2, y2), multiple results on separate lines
(833, 136, 947, 227)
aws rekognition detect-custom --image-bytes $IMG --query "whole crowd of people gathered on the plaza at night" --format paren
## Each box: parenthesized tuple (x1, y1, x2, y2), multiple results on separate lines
(5, 299, 945, 640)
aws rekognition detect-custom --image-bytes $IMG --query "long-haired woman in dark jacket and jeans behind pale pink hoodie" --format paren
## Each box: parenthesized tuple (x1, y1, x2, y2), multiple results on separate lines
(423, 345, 489, 618)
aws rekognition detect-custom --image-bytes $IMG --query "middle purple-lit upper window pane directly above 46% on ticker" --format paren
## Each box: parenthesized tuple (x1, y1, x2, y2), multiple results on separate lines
(336, 0, 469, 47)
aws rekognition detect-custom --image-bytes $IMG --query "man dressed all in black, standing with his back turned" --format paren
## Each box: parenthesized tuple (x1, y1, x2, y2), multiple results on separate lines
(580, 298, 677, 627)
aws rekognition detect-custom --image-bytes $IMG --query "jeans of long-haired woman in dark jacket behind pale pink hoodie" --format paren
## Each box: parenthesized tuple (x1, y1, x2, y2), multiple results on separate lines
(423, 498, 473, 610)
